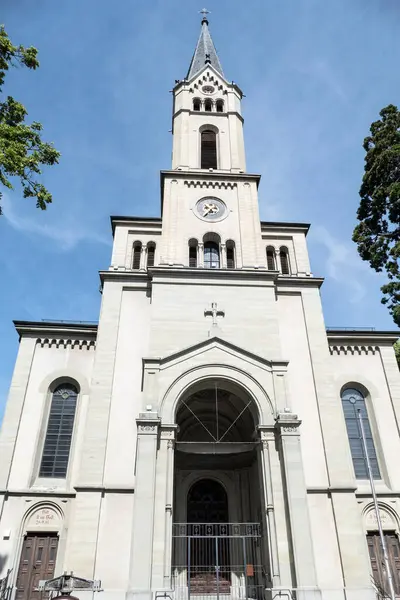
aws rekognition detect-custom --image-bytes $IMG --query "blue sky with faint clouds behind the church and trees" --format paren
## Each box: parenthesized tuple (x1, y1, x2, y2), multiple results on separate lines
(0, 0, 400, 418)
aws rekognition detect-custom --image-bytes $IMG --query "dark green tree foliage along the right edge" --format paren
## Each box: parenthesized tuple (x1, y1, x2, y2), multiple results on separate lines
(353, 104, 400, 326)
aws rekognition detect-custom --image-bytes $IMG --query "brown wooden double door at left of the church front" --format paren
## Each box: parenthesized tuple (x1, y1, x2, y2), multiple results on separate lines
(16, 533, 58, 600)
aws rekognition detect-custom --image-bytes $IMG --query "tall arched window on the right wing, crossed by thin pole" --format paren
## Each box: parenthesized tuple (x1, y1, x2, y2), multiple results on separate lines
(342, 388, 381, 479)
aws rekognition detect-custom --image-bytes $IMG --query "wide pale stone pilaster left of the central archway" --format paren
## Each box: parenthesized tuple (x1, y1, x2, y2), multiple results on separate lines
(127, 412, 159, 600)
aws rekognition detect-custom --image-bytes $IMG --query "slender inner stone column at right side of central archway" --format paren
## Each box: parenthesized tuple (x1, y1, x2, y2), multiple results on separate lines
(259, 427, 281, 587)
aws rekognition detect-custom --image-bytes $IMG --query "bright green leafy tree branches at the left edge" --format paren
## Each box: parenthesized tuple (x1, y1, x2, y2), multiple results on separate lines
(0, 26, 60, 214)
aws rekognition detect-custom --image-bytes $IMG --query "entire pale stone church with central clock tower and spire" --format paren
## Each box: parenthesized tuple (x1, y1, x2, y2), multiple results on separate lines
(0, 11, 400, 600)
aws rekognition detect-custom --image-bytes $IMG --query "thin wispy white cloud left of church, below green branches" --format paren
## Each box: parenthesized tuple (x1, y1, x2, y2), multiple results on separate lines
(2, 194, 110, 252)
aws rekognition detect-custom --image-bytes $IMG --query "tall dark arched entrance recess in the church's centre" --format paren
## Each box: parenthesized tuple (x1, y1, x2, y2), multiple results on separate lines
(172, 379, 269, 599)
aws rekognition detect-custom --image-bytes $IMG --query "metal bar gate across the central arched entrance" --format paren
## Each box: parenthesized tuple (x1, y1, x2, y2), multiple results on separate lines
(172, 523, 265, 600)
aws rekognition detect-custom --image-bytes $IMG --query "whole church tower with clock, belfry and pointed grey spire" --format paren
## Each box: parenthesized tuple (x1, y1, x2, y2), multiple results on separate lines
(160, 10, 266, 269)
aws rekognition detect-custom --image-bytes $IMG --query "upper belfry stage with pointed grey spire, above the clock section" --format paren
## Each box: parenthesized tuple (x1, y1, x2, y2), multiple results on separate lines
(172, 11, 246, 173)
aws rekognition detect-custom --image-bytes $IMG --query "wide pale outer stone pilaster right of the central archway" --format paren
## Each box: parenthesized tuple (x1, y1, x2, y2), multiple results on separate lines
(276, 412, 321, 600)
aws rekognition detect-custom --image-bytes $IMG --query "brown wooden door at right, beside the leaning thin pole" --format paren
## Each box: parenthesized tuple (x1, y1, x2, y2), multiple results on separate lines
(367, 532, 400, 595)
